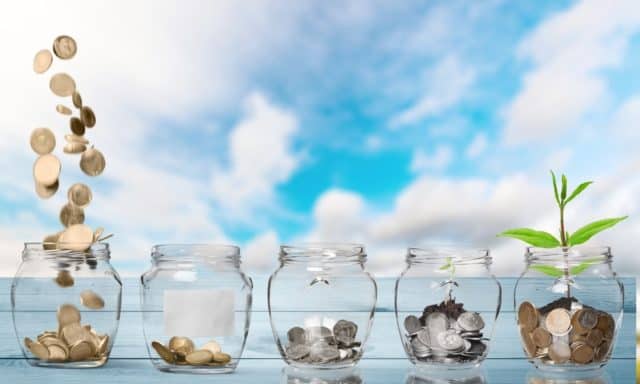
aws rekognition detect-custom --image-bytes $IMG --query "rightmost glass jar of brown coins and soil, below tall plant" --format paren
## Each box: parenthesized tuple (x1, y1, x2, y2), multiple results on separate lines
(514, 246, 624, 371)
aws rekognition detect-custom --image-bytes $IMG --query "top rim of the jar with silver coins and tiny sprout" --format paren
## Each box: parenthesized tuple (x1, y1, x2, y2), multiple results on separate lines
(406, 246, 493, 265)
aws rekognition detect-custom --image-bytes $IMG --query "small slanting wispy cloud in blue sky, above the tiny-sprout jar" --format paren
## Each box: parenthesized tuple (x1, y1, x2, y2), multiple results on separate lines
(390, 56, 475, 128)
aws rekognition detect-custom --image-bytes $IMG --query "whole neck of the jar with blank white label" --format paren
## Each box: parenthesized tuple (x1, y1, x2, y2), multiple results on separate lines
(151, 244, 241, 268)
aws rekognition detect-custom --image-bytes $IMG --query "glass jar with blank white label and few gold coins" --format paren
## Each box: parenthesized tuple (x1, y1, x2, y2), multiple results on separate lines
(141, 244, 253, 373)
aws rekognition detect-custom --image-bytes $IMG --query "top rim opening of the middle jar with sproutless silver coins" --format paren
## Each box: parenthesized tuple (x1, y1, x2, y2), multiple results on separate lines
(280, 242, 367, 262)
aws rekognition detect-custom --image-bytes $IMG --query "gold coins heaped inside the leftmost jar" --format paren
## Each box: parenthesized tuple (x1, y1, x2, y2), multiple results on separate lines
(24, 302, 109, 363)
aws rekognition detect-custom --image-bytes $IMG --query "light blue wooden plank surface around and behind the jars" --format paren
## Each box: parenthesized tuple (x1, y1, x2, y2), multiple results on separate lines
(0, 277, 636, 384)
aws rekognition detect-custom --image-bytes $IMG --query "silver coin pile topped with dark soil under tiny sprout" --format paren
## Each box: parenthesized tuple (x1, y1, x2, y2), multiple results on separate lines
(404, 299, 488, 364)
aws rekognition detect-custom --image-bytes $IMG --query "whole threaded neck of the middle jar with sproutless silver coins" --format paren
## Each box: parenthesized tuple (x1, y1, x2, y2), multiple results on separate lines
(279, 243, 367, 267)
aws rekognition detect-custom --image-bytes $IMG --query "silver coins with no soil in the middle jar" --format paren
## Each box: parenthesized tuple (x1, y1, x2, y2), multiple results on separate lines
(285, 320, 361, 364)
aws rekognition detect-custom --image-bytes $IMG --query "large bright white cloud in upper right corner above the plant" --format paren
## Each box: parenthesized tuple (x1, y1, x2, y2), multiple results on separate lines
(504, 0, 640, 145)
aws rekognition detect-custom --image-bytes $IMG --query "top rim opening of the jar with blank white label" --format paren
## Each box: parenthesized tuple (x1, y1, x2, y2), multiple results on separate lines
(151, 244, 240, 261)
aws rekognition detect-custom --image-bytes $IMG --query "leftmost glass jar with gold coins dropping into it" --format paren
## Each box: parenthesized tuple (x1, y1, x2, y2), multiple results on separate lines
(11, 243, 122, 368)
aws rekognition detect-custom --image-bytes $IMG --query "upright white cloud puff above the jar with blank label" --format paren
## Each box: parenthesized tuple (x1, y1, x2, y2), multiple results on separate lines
(212, 93, 301, 219)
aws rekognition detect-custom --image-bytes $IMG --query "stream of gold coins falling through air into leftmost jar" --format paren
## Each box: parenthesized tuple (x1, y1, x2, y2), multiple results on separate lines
(30, 36, 106, 252)
